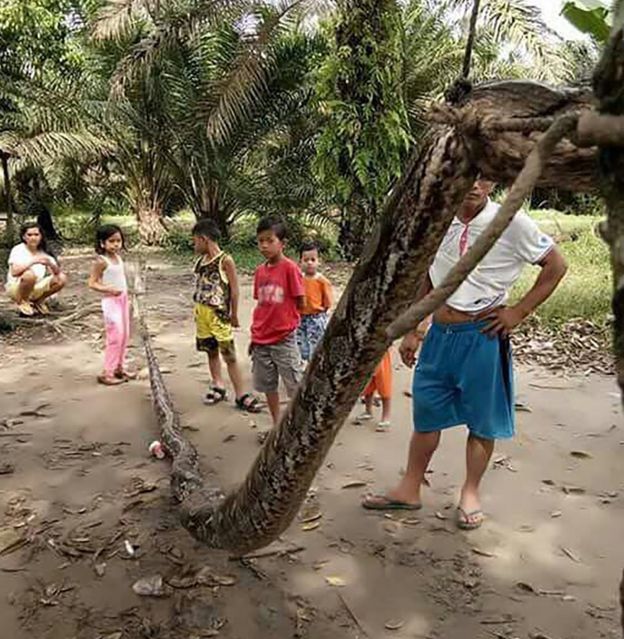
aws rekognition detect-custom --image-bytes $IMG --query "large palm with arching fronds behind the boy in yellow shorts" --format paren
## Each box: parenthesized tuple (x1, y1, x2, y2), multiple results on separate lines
(94, 0, 330, 237)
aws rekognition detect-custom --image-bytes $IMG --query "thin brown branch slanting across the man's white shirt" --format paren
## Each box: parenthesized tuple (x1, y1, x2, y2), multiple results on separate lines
(386, 113, 578, 340)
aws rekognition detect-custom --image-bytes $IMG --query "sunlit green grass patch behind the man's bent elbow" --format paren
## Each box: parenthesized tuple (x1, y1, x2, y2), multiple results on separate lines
(511, 211, 612, 327)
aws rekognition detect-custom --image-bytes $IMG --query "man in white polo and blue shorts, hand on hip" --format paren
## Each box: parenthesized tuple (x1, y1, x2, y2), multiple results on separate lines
(363, 180, 567, 530)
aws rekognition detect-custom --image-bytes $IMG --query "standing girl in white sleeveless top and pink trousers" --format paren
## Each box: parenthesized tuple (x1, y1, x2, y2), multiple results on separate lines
(89, 224, 136, 386)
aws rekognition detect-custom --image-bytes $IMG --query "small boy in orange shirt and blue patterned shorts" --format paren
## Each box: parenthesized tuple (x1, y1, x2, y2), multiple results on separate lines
(297, 242, 333, 362)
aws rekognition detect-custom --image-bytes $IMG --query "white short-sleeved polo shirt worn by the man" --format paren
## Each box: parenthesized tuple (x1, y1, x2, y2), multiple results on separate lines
(429, 200, 555, 313)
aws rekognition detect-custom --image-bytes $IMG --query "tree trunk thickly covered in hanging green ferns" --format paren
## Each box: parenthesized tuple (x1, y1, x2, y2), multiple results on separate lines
(315, 0, 410, 205)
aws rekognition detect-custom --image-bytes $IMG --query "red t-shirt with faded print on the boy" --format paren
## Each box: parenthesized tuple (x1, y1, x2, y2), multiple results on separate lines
(251, 257, 305, 344)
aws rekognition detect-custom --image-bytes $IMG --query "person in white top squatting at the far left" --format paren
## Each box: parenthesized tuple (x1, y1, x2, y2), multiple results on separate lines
(6, 223, 67, 317)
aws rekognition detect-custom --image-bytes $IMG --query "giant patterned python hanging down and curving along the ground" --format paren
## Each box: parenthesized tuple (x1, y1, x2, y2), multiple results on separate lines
(142, 128, 475, 553)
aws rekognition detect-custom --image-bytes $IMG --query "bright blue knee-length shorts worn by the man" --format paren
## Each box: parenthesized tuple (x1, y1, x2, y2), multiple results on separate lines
(412, 322, 515, 439)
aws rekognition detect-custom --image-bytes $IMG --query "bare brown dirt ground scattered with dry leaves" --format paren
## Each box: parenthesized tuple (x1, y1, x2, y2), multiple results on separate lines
(0, 259, 624, 639)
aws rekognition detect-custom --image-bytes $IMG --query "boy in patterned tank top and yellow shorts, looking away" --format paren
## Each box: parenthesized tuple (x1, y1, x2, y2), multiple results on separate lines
(192, 219, 261, 413)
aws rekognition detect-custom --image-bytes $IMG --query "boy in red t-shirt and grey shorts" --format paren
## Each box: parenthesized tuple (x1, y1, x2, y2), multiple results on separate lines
(250, 217, 305, 425)
